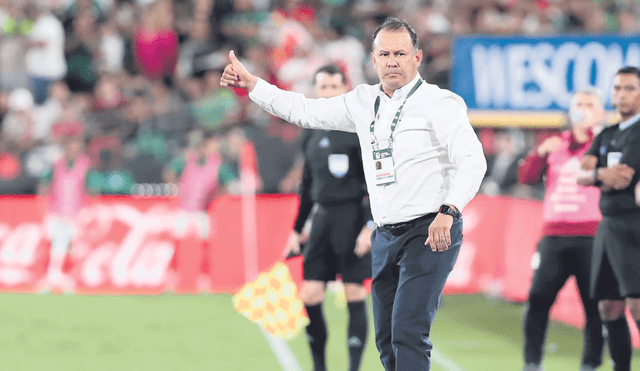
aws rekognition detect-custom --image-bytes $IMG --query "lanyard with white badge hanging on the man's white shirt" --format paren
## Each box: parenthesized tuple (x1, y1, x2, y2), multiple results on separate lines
(369, 79, 422, 186)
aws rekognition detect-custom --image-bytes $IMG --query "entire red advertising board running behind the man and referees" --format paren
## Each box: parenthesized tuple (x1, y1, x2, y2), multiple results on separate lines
(0, 195, 640, 347)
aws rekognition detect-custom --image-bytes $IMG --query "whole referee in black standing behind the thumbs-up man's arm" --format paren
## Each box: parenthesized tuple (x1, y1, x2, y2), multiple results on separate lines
(289, 65, 375, 371)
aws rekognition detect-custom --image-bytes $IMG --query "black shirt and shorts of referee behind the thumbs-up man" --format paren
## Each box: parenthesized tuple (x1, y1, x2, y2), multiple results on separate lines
(294, 130, 371, 284)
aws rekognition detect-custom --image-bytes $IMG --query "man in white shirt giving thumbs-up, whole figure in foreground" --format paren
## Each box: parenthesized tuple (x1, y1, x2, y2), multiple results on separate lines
(220, 18, 486, 371)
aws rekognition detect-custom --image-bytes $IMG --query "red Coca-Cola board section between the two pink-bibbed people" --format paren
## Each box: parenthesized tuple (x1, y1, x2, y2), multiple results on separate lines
(70, 199, 177, 292)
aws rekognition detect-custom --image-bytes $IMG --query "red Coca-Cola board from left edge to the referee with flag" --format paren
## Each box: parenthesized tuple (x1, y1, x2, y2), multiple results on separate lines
(0, 195, 301, 294)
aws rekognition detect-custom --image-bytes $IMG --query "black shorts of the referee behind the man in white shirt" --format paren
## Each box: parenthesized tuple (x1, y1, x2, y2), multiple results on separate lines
(303, 202, 371, 283)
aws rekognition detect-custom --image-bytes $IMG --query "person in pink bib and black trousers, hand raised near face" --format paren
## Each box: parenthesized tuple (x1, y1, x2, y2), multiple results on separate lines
(518, 89, 604, 371)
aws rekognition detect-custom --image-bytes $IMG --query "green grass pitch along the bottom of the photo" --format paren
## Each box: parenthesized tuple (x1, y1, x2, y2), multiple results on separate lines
(0, 293, 640, 371)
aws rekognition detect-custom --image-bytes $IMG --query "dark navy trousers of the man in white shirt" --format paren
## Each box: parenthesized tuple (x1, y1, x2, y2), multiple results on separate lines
(371, 218, 462, 371)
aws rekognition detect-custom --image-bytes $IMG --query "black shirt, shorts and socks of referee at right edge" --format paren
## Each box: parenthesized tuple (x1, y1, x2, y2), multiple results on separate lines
(587, 120, 640, 371)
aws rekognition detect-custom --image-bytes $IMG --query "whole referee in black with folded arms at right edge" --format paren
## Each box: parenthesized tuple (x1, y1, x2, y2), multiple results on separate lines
(578, 67, 640, 371)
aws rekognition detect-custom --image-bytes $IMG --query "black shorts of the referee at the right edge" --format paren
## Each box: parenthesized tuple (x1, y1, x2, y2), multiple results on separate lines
(591, 216, 640, 300)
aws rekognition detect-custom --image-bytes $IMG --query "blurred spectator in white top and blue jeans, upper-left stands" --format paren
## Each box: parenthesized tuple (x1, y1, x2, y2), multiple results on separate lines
(26, 1, 67, 104)
